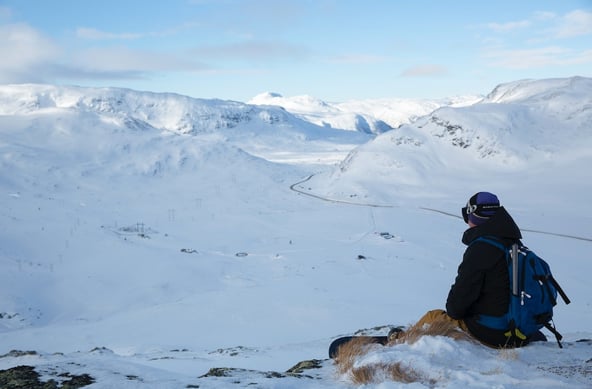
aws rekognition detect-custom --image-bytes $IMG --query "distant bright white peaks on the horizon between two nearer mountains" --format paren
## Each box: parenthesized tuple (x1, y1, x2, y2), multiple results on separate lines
(249, 92, 482, 134)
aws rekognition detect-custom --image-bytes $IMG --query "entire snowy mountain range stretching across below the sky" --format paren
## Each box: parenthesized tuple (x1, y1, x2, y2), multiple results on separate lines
(0, 77, 592, 186)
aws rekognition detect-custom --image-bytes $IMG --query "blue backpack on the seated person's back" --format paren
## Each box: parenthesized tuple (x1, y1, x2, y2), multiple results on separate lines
(471, 237, 570, 347)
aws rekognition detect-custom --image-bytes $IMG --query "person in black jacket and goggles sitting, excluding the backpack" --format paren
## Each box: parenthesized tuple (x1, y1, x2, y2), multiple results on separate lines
(389, 192, 546, 347)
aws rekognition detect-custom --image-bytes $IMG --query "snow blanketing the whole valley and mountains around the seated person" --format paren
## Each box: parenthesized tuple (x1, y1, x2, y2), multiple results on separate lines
(0, 77, 592, 388)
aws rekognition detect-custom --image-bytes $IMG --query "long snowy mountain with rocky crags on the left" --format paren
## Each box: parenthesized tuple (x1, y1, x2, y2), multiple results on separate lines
(0, 85, 370, 168)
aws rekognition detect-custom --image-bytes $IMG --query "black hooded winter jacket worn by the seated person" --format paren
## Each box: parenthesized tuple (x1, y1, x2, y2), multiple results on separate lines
(446, 207, 522, 347)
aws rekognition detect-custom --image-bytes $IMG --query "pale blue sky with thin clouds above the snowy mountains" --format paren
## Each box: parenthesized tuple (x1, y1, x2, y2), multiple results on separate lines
(0, 0, 592, 102)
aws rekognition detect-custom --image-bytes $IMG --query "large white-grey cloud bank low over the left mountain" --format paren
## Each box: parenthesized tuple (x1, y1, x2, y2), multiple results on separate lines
(0, 23, 209, 83)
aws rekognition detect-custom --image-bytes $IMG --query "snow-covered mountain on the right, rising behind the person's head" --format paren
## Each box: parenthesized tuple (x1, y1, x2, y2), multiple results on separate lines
(310, 77, 592, 208)
